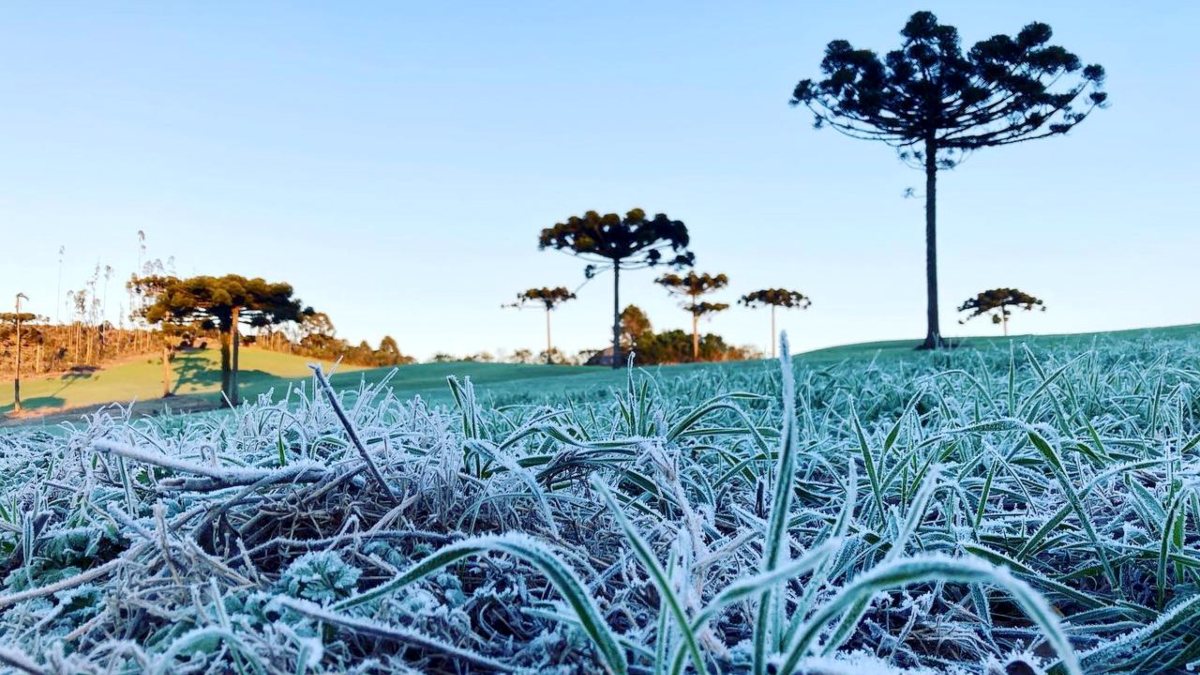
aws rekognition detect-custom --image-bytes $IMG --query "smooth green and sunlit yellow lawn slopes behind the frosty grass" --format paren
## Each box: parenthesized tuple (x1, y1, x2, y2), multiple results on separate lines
(0, 324, 1200, 414)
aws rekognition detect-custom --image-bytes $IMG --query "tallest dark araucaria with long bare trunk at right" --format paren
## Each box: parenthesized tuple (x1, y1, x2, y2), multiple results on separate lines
(791, 12, 1106, 348)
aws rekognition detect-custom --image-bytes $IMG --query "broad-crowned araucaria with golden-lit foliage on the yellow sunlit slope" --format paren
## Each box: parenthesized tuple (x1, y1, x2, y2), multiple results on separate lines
(130, 274, 312, 405)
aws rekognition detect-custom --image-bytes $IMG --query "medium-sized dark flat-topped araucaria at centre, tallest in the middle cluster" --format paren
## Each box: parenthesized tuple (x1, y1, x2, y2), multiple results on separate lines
(538, 209, 696, 368)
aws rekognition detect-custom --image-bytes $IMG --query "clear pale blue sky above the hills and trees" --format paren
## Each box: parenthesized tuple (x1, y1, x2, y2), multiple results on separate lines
(0, 0, 1200, 358)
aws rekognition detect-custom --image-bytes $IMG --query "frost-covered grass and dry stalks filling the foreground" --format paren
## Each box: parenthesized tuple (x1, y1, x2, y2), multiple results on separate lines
(0, 338, 1200, 675)
